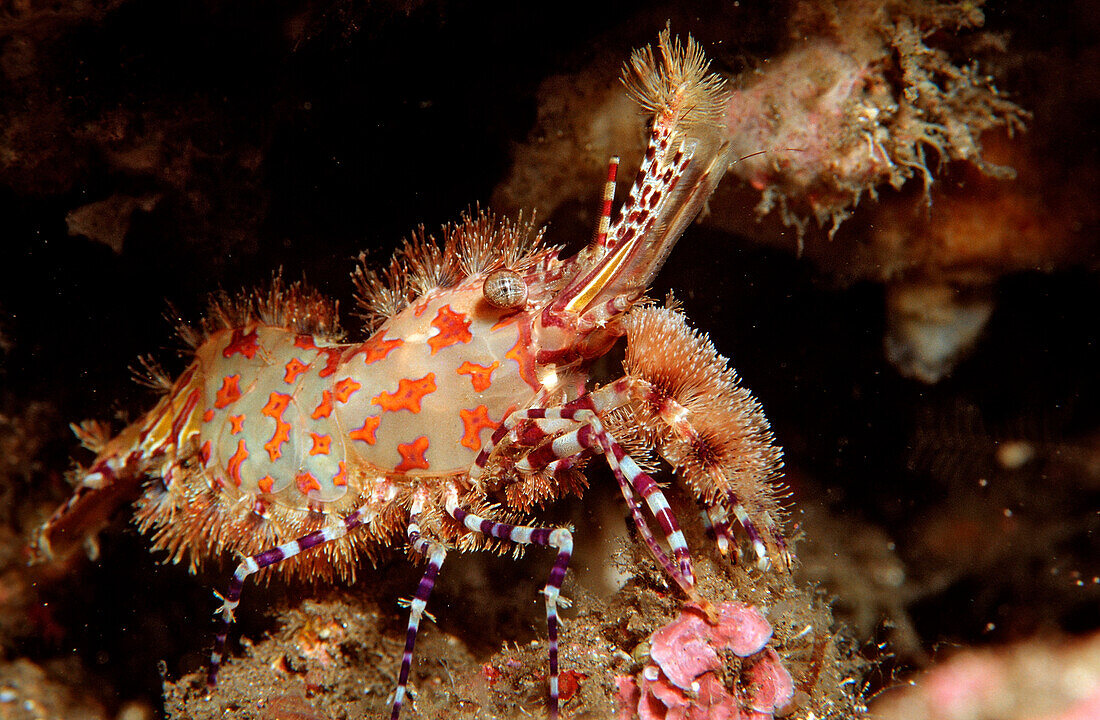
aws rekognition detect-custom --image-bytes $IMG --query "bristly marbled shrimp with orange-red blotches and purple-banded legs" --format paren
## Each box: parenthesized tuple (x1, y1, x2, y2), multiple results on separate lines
(36, 32, 787, 719)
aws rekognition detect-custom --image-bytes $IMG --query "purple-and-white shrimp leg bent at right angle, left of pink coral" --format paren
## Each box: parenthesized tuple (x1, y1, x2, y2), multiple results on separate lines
(447, 490, 573, 720)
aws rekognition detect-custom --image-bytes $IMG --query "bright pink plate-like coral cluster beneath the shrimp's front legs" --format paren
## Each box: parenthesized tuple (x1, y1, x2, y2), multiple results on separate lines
(617, 602, 794, 720)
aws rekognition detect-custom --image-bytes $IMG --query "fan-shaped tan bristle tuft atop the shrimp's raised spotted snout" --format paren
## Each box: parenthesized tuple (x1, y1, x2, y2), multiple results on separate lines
(623, 27, 726, 136)
